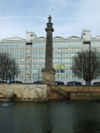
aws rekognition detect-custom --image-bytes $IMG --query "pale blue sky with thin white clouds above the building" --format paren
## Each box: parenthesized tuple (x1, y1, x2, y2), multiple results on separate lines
(0, 0, 100, 39)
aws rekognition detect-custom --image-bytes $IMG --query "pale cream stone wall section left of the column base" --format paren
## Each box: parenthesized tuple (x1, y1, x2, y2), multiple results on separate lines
(0, 84, 47, 100)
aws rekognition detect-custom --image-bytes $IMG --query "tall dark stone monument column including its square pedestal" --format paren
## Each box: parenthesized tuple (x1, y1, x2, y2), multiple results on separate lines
(42, 16, 55, 85)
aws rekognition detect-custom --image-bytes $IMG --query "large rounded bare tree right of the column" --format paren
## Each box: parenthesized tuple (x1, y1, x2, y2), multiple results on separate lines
(72, 51, 100, 85)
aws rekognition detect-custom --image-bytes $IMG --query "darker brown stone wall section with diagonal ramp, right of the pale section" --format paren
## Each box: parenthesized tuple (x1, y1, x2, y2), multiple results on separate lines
(48, 86, 100, 100)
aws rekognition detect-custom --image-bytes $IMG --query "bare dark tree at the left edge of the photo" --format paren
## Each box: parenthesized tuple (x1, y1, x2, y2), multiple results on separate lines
(0, 53, 18, 81)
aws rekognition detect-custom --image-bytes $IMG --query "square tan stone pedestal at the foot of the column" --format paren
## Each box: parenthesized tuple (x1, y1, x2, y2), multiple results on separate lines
(42, 69, 55, 85)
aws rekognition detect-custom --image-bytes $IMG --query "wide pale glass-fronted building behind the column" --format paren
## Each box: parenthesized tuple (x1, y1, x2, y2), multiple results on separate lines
(0, 30, 100, 84)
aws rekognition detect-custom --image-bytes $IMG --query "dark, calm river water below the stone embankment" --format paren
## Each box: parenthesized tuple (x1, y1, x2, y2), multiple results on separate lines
(0, 102, 100, 133)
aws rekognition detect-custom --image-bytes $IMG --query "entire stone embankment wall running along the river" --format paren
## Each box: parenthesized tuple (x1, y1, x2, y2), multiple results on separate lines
(0, 84, 100, 102)
